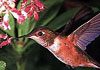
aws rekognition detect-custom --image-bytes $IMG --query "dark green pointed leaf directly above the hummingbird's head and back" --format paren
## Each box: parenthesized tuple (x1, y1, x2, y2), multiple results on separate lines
(48, 8, 78, 31)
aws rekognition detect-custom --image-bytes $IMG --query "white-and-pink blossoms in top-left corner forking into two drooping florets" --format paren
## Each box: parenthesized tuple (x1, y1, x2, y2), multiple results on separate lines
(0, 0, 25, 30)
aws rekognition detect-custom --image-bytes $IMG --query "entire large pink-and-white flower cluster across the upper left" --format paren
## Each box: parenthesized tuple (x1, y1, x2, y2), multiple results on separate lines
(0, 0, 45, 30)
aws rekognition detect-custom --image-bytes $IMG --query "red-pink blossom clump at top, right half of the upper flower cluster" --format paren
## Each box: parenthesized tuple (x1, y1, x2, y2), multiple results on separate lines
(20, 0, 45, 20)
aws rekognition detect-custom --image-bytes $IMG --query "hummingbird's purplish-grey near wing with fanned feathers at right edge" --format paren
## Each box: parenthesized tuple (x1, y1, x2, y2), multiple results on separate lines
(72, 13, 100, 50)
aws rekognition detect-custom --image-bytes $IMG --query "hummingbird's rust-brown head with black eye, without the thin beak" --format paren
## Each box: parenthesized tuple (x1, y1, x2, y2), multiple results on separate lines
(27, 26, 56, 47)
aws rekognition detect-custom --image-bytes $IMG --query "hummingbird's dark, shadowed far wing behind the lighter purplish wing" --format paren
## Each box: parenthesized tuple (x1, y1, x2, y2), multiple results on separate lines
(62, 5, 93, 33)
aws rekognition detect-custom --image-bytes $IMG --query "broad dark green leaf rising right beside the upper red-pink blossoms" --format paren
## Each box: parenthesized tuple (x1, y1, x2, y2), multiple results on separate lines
(36, 0, 63, 26)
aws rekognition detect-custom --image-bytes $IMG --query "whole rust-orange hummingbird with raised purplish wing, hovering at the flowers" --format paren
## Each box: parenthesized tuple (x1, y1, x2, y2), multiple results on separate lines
(11, 13, 100, 69)
